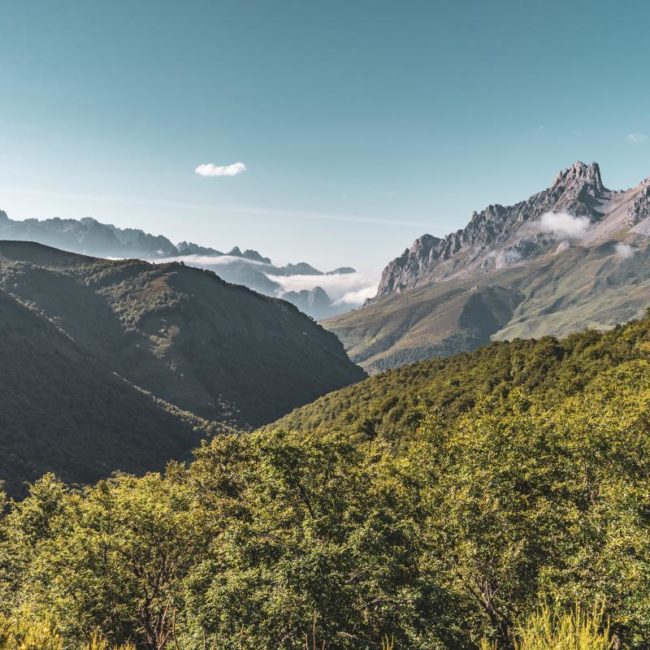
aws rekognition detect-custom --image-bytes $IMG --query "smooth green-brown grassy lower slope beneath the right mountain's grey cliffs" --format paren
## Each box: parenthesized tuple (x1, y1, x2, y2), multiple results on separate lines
(324, 238, 650, 372)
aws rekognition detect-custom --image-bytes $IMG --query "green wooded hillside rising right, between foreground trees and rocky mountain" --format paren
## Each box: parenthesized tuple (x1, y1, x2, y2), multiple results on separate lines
(263, 309, 650, 441)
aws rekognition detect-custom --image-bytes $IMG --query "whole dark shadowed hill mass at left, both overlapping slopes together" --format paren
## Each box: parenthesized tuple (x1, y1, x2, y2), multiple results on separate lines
(0, 241, 365, 492)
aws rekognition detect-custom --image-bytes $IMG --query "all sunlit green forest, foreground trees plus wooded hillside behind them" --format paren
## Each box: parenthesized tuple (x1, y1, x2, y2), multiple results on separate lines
(0, 317, 650, 650)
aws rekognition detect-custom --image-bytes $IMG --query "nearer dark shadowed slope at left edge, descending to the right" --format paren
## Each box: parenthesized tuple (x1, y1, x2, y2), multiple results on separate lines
(0, 290, 212, 494)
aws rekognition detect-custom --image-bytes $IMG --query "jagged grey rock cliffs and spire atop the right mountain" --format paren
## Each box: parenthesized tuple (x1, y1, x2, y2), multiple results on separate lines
(377, 162, 612, 297)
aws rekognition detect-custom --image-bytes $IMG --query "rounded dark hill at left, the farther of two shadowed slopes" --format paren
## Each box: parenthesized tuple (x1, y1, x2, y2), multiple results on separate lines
(0, 242, 363, 427)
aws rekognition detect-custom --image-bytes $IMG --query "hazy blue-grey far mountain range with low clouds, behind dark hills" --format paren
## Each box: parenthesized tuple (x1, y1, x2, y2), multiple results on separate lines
(0, 211, 362, 318)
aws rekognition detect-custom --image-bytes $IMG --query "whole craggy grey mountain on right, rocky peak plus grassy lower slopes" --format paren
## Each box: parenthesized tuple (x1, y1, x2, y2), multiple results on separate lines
(325, 162, 650, 372)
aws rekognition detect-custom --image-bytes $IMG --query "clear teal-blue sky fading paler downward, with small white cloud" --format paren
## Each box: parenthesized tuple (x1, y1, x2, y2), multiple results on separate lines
(0, 0, 650, 276)
